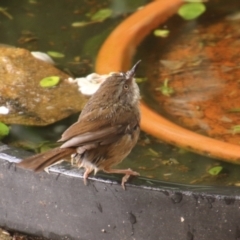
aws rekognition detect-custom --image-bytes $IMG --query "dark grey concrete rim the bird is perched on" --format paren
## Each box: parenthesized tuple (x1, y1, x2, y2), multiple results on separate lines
(0, 145, 240, 240)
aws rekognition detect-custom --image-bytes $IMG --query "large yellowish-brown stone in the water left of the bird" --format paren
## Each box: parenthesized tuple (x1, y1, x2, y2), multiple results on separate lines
(0, 47, 87, 126)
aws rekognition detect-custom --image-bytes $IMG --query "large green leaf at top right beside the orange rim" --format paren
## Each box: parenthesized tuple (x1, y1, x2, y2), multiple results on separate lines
(178, 2, 206, 20)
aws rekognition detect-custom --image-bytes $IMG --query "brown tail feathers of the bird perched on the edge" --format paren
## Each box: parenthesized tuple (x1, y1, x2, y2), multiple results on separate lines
(17, 148, 76, 172)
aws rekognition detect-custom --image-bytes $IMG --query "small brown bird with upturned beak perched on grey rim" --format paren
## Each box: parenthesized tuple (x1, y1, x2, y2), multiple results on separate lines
(18, 61, 140, 188)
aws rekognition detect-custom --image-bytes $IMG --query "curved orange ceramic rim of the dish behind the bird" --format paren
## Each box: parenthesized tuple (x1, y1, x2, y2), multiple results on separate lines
(96, 0, 240, 164)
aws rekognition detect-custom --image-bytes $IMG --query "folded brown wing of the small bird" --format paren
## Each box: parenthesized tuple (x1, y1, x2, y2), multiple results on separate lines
(59, 105, 140, 148)
